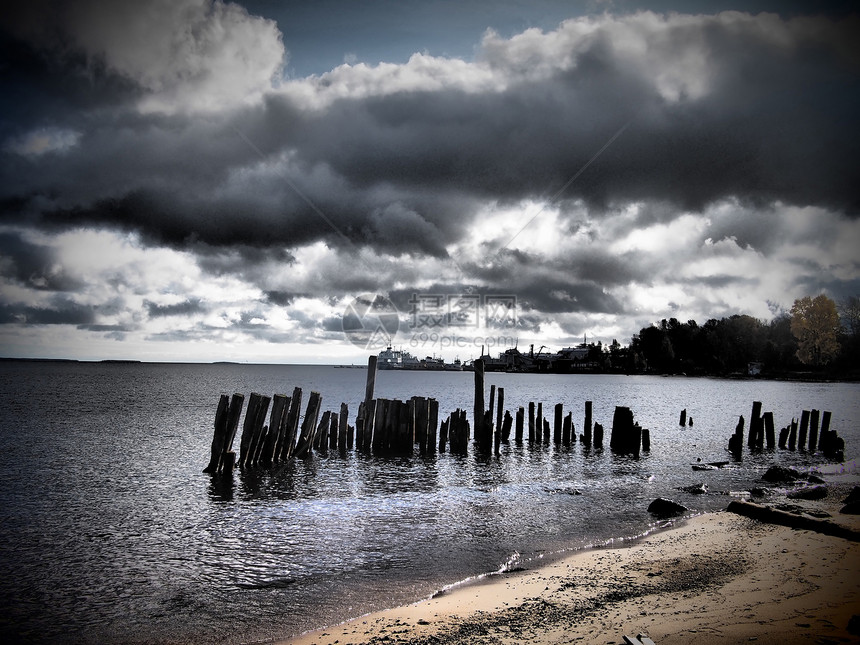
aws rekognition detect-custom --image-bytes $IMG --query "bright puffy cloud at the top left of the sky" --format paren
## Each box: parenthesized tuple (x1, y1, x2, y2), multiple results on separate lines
(7, 0, 286, 114)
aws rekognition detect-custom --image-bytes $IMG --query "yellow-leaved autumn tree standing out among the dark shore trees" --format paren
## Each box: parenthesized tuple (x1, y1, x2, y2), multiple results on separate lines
(791, 294, 841, 367)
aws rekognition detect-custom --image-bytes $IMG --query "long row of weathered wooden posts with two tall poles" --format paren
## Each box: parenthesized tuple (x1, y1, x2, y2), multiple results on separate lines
(204, 356, 650, 473)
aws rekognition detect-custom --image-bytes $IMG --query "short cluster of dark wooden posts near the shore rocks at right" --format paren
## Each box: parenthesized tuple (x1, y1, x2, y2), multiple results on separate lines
(729, 401, 845, 459)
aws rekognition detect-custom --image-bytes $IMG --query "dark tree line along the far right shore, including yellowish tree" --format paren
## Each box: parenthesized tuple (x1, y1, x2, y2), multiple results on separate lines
(593, 294, 860, 378)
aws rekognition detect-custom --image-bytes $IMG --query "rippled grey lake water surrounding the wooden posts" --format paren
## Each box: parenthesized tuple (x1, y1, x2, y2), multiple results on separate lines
(0, 362, 860, 644)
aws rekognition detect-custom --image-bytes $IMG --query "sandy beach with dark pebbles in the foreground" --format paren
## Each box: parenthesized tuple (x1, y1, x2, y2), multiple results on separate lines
(283, 482, 860, 645)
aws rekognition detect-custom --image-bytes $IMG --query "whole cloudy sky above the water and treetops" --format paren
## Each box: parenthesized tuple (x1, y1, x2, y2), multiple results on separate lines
(0, 0, 860, 364)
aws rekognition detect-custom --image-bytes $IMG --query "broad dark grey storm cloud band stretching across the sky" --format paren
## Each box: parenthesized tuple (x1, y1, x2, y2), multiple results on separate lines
(3, 9, 860, 266)
